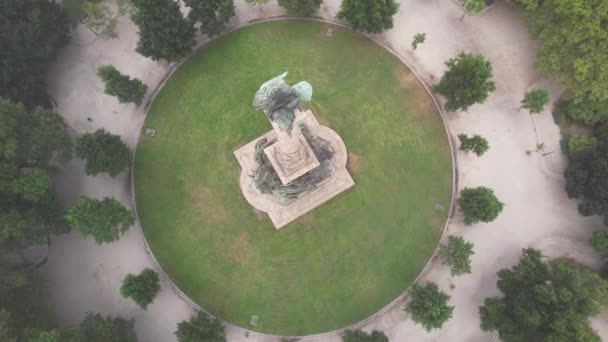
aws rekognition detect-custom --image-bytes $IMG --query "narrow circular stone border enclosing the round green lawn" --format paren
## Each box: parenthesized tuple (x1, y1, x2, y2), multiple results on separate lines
(131, 16, 458, 338)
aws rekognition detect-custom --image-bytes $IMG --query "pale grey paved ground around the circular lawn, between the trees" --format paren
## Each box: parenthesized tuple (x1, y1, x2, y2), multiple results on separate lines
(40, 0, 608, 342)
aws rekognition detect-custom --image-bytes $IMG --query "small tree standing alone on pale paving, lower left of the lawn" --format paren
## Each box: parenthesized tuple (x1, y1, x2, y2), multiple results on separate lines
(120, 268, 160, 310)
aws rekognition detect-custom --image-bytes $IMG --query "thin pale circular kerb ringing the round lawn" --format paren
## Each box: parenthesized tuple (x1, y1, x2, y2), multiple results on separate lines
(131, 16, 458, 339)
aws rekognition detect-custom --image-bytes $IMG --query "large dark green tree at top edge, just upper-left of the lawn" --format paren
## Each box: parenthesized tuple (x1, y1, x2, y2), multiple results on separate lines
(131, 0, 195, 62)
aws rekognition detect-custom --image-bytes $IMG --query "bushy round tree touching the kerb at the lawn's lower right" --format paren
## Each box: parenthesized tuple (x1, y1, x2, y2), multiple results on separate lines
(405, 282, 454, 331)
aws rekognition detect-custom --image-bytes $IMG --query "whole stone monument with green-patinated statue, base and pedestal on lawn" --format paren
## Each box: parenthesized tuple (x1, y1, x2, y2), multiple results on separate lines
(234, 73, 355, 229)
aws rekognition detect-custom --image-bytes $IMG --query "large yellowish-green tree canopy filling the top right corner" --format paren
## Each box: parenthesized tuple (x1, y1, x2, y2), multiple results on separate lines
(513, 0, 608, 102)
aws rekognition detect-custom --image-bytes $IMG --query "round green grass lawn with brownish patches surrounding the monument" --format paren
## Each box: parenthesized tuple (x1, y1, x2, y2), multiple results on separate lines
(134, 21, 452, 335)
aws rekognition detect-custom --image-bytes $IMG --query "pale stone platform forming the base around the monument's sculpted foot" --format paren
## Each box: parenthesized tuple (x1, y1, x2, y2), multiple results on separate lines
(234, 110, 355, 230)
